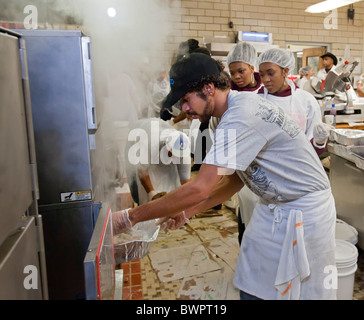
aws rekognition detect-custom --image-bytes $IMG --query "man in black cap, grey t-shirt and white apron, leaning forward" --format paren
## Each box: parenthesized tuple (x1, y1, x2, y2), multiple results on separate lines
(112, 53, 336, 300)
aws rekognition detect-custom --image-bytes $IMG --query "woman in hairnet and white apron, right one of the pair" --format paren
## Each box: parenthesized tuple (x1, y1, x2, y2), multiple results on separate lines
(233, 48, 329, 230)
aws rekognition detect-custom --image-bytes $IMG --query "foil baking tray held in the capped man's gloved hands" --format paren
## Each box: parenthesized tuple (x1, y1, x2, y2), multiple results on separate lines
(114, 220, 160, 264)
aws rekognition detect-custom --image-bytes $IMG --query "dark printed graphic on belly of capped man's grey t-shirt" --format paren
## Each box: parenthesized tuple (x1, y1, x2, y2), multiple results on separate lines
(243, 161, 286, 202)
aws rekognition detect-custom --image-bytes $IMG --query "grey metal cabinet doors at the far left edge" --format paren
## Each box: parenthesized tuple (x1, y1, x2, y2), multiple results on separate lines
(0, 27, 48, 300)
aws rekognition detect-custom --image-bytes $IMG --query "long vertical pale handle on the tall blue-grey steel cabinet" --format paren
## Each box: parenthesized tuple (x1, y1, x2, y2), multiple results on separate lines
(81, 37, 97, 134)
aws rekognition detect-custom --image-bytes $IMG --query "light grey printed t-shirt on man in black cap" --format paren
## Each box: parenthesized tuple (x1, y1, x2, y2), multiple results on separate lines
(204, 91, 330, 203)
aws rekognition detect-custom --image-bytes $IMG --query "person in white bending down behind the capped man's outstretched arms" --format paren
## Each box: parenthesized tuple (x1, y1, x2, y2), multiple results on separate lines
(125, 118, 191, 205)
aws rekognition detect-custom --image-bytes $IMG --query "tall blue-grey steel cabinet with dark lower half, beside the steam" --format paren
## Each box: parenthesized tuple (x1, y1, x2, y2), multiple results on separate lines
(17, 30, 103, 299)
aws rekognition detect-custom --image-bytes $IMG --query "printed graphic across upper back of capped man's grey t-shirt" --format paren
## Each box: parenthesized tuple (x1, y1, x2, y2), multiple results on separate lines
(255, 103, 301, 138)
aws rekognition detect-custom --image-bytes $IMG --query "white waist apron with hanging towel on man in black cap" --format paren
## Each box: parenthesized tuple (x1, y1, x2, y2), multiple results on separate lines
(234, 189, 336, 300)
